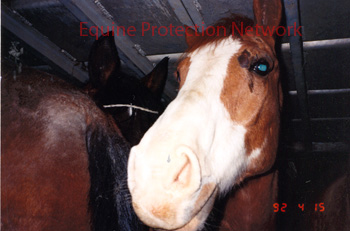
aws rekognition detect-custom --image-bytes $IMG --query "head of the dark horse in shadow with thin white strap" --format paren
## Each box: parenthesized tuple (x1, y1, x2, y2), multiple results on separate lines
(87, 33, 169, 145)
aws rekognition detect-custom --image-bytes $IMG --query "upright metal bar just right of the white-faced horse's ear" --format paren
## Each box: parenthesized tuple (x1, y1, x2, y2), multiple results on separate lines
(283, 0, 312, 148)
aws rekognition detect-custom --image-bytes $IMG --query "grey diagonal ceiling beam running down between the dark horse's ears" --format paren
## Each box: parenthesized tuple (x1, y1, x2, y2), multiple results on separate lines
(60, 0, 153, 74)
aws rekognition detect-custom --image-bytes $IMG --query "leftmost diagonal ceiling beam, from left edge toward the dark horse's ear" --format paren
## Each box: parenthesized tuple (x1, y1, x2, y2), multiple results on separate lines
(1, 4, 89, 82)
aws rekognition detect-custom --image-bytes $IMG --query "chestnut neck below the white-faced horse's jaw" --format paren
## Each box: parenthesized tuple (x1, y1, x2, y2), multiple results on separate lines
(220, 171, 278, 231)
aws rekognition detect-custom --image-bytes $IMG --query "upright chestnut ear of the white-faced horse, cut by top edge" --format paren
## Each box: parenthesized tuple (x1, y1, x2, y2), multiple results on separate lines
(253, 0, 282, 30)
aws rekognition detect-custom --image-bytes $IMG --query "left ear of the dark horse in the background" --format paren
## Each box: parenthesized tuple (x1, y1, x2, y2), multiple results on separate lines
(89, 32, 120, 91)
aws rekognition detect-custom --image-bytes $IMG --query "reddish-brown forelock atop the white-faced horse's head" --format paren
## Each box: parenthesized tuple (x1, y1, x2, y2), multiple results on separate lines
(186, 14, 255, 53)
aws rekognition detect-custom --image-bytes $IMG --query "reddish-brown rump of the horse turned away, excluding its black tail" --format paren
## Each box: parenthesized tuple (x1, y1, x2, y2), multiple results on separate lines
(1, 64, 128, 231)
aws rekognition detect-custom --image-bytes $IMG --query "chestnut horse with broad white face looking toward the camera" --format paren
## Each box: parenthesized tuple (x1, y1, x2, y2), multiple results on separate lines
(128, 0, 282, 230)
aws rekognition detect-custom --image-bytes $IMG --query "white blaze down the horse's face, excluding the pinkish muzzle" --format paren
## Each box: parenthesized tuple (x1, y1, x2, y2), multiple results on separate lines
(129, 37, 248, 195)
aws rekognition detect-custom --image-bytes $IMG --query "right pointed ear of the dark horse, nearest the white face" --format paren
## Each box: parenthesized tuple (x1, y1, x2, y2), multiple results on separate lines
(141, 57, 169, 99)
